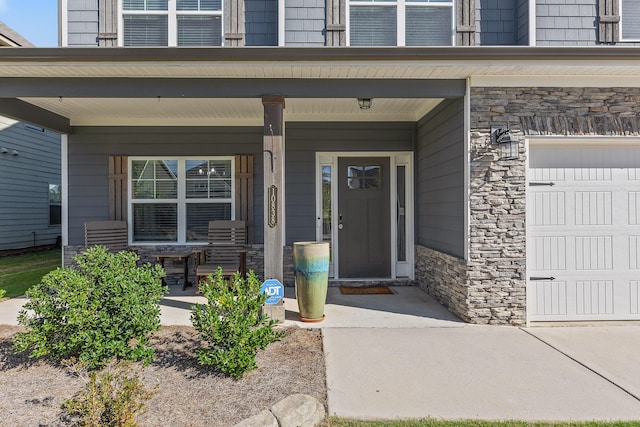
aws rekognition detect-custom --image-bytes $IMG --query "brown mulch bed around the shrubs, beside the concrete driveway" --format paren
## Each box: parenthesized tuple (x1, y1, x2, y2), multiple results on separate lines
(0, 326, 327, 427)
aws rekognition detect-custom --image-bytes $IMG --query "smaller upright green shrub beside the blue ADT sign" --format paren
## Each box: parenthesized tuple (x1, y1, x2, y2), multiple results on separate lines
(191, 268, 284, 378)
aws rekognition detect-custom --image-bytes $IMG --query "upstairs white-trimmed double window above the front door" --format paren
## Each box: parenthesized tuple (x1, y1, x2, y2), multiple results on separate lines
(349, 0, 453, 46)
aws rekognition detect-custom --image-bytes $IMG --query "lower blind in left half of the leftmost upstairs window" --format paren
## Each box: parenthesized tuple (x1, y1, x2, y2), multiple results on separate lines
(123, 15, 169, 46)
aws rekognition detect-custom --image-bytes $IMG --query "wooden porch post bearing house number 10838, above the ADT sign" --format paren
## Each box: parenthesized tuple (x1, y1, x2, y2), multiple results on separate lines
(262, 95, 284, 283)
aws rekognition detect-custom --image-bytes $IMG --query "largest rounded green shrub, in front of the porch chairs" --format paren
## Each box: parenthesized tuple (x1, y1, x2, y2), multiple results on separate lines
(14, 246, 166, 369)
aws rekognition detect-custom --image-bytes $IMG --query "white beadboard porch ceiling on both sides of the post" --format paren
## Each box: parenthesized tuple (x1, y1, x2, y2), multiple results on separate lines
(21, 98, 442, 126)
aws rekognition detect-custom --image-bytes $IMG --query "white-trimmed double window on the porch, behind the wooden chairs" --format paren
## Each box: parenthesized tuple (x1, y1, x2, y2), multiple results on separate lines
(129, 157, 235, 244)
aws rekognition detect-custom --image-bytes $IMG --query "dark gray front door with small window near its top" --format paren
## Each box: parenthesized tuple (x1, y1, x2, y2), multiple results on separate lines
(338, 157, 391, 278)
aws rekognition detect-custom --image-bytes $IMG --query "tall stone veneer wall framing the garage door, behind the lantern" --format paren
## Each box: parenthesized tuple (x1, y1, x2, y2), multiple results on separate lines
(463, 87, 640, 325)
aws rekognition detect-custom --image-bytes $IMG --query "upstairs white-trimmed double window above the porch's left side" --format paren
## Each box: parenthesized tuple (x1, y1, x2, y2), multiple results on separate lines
(120, 0, 222, 47)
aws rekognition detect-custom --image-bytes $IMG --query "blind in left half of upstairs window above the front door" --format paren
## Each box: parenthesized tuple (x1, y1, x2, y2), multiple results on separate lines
(349, 6, 397, 46)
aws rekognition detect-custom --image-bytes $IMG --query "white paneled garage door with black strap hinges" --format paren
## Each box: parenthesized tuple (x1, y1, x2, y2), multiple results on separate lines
(527, 140, 640, 321)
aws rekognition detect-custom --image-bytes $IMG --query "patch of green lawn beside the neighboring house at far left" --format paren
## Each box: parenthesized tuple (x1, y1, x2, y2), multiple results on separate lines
(0, 249, 62, 298)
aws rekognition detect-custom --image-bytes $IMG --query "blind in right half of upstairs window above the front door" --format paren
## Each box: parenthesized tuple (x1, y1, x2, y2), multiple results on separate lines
(405, 6, 452, 46)
